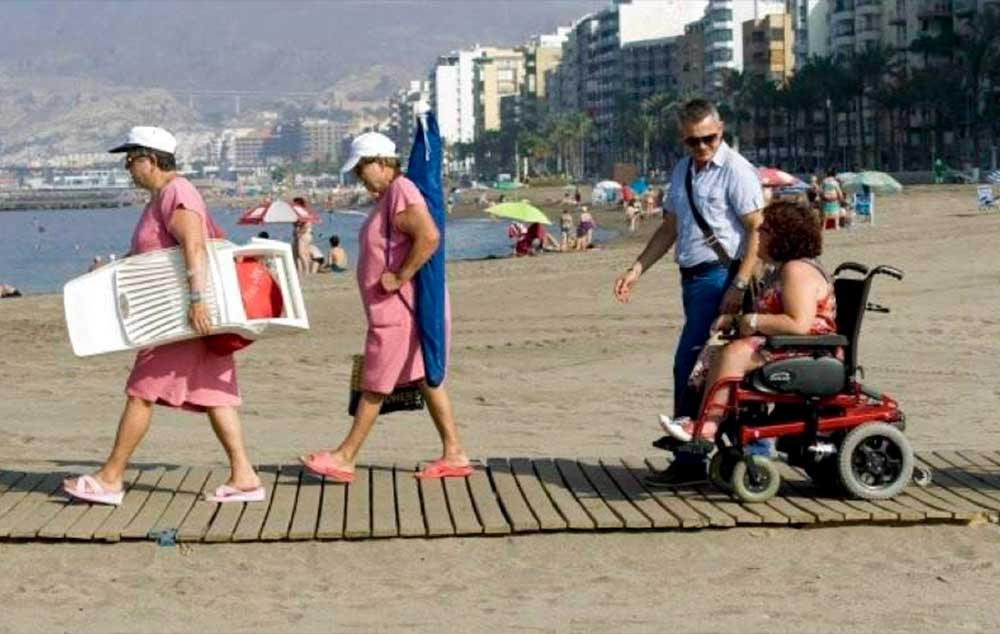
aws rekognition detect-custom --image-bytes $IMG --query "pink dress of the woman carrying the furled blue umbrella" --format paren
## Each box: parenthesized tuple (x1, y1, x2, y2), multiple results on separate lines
(357, 176, 440, 394)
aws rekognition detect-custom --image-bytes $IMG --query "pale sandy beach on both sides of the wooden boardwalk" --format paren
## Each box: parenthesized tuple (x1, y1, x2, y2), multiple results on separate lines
(0, 181, 1000, 633)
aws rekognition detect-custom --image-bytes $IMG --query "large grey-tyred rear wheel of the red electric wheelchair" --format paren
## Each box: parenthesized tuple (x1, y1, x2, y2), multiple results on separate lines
(837, 423, 913, 500)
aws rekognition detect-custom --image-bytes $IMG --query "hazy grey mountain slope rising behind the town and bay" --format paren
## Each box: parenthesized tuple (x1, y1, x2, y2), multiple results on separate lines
(0, 0, 606, 161)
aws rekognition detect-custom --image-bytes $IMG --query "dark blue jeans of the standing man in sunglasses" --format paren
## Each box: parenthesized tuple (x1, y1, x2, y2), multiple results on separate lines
(674, 265, 771, 464)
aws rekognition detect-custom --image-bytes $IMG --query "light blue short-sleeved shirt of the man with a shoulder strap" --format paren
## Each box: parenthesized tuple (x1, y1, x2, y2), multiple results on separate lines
(664, 141, 764, 267)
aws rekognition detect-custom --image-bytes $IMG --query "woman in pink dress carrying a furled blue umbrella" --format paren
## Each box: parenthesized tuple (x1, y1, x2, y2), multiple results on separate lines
(300, 132, 472, 482)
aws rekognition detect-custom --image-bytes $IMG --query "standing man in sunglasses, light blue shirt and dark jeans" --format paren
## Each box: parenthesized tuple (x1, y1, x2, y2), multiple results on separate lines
(614, 99, 764, 486)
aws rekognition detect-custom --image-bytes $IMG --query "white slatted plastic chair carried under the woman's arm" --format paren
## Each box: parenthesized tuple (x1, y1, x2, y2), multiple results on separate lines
(63, 238, 309, 357)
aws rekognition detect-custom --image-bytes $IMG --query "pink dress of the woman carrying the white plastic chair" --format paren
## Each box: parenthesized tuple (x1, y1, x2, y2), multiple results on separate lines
(125, 176, 240, 412)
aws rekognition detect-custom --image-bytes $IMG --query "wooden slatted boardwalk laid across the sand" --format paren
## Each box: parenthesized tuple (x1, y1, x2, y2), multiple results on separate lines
(0, 451, 1000, 542)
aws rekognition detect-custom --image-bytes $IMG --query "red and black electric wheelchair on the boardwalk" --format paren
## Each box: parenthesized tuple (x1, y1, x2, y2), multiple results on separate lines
(660, 262, 931, 502)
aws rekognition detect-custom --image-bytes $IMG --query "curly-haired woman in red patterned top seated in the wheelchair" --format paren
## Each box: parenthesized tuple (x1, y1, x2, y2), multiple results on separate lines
(660, 201, 841, 441)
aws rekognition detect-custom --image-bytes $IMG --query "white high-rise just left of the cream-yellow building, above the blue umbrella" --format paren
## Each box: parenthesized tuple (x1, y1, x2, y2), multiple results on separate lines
(431, 46, 483, 144)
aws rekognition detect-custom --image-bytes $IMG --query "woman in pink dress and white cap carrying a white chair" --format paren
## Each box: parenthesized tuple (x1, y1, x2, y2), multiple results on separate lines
(63, 127, 265, 504)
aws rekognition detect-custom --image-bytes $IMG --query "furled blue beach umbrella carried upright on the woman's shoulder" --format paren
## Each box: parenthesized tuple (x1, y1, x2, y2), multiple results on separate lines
(406, 103, 449, 387)
